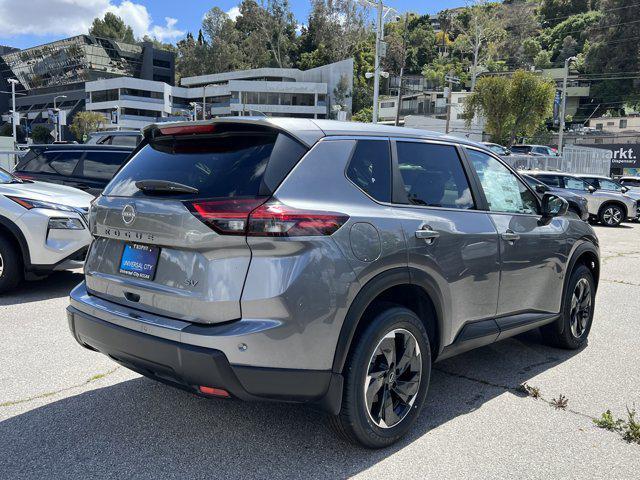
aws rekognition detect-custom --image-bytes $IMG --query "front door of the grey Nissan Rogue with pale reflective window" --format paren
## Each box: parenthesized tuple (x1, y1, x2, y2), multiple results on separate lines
(465, 147, 570, 317)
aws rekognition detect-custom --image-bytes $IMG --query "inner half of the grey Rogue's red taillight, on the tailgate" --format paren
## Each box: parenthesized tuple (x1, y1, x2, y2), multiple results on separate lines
(185, 198, 266, 235)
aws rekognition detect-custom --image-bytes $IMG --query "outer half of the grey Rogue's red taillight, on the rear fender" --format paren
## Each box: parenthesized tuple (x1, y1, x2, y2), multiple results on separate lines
(247, 202, 349, 237)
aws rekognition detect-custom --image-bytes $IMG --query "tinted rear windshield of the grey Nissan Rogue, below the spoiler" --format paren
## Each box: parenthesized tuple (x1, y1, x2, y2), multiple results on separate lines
(104, 132, 305, 198)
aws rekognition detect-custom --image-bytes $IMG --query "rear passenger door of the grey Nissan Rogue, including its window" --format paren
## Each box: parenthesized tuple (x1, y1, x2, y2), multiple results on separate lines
(392, 140, 500, 343)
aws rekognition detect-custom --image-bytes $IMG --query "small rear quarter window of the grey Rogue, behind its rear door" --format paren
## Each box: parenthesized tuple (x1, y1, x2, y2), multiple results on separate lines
(347, 140, 391, 202)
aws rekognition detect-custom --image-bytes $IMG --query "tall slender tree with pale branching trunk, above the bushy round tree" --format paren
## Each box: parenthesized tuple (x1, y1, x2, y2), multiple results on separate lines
(454, 0, 505, 91)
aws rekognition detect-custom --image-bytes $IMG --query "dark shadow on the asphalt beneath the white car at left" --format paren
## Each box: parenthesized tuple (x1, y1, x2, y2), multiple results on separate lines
(0, 270, 83, 306)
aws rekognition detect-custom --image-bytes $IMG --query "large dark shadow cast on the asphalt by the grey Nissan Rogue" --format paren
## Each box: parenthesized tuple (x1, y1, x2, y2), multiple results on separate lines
(0, 333, 579, 478)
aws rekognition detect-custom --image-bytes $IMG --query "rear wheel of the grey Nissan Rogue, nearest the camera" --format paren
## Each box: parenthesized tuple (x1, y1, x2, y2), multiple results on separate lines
(330, 304, 431, 448)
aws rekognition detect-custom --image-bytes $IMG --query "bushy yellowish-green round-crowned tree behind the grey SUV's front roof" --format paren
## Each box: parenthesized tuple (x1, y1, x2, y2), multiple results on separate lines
(465, 70, 556, 145)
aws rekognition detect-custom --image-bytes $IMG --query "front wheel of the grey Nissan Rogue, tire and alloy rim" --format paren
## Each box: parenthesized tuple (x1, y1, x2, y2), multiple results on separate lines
(540, 264, 596, 350)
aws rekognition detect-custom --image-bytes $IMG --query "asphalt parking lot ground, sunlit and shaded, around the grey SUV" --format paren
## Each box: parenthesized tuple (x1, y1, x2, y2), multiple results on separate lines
(0, 224, 640, 479)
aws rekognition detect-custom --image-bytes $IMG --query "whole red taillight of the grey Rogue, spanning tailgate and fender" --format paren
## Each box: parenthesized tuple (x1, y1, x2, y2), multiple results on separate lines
(185, 198, 349, 237)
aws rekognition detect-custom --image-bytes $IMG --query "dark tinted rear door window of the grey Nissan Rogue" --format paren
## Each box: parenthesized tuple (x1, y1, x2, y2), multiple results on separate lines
(396, 142, 475, 209)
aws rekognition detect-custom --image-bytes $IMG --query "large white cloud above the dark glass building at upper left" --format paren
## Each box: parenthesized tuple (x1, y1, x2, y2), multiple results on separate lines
(0, 0, 185, 41)
